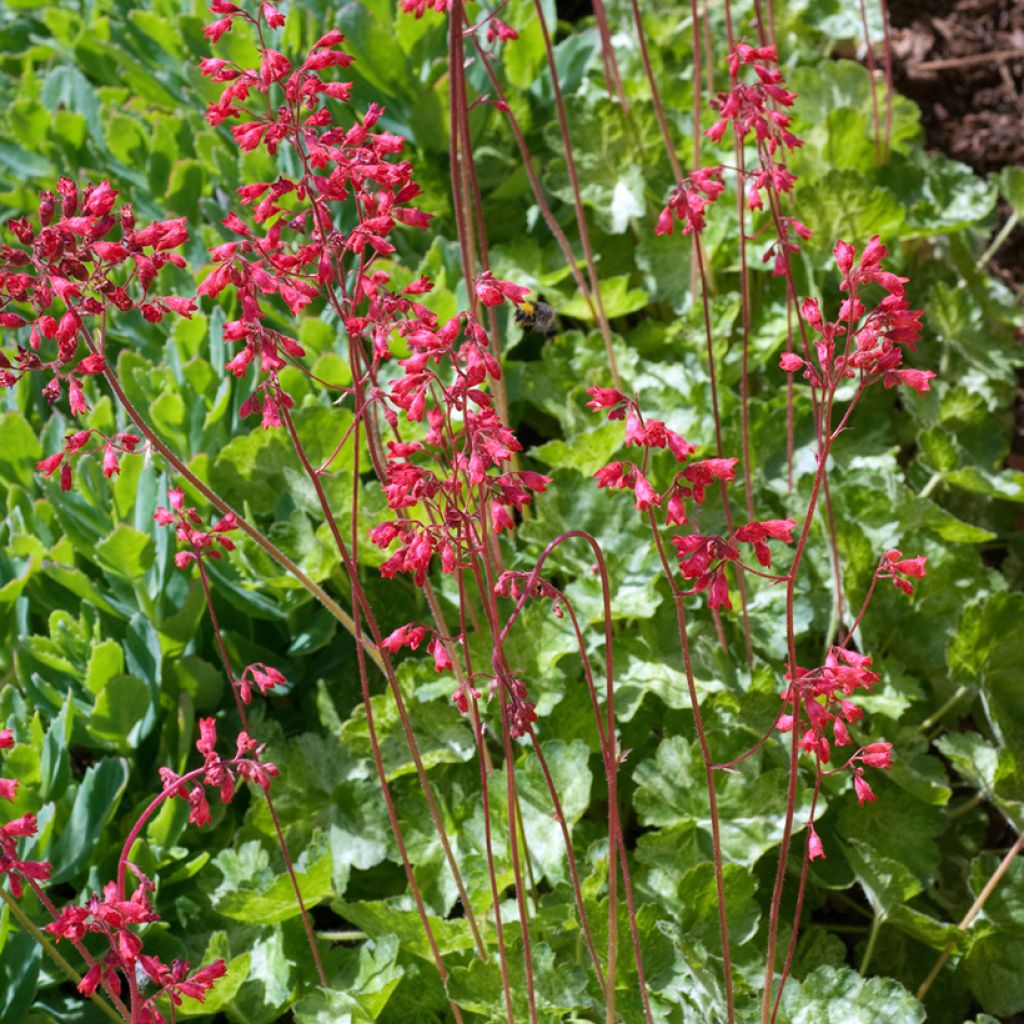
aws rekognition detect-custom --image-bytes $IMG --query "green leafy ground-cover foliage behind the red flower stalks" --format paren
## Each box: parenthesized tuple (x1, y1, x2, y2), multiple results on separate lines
(0, 0, 1024, 1024)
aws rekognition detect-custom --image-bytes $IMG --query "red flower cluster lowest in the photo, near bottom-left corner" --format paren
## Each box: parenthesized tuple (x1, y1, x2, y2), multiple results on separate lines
(46, 865, 227, 1024)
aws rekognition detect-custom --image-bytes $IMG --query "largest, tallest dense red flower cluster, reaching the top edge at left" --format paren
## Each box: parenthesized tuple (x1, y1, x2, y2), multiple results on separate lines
(199, 0, 438, 428)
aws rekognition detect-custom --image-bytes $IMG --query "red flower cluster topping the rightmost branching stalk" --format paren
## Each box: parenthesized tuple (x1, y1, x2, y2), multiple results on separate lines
(780, 236, 935, 393)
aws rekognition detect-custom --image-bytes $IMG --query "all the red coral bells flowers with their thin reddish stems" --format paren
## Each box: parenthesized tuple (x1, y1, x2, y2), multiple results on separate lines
(0, 6, 950, 1024)
